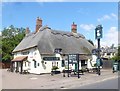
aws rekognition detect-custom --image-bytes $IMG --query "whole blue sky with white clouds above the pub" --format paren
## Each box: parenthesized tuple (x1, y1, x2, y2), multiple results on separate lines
(0, 0, 119, 46)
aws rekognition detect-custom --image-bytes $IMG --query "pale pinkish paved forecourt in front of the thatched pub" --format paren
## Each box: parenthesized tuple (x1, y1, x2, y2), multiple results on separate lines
(0, 69, 118, 89)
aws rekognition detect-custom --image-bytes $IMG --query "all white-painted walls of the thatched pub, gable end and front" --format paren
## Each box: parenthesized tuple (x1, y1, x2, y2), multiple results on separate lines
(14, 48, 94, 74)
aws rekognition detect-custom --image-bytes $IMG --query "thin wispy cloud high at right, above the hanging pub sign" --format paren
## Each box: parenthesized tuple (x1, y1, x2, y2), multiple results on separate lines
(97, 13, 117, 22)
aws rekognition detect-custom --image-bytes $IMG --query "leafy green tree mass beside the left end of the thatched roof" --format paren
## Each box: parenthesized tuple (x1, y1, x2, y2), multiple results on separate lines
(2, 25, 25, 62)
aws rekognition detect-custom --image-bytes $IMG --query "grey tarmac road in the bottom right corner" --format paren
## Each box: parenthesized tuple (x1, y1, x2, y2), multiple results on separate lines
(75, 78, 120, 89)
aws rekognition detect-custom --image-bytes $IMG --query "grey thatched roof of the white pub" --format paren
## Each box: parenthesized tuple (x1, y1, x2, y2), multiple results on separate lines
(13, 26, 94, 54)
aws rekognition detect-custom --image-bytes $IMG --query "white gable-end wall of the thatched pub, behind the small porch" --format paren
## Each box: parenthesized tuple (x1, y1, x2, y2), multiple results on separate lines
(14, 48, 41, 74)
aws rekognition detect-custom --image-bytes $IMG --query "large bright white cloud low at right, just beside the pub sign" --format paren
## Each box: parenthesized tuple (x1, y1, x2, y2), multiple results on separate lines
(95, 27, 120, 46)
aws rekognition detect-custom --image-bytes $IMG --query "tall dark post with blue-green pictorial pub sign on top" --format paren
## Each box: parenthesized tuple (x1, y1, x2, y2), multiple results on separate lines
(95, 25, 103, 75)
